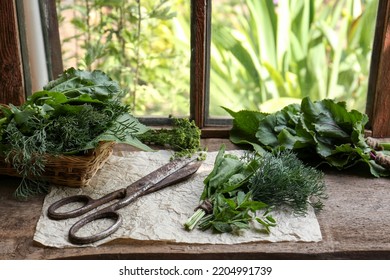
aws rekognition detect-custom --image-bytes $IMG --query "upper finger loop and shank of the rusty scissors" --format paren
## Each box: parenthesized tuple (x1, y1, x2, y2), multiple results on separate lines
(47, 189, 126, 220)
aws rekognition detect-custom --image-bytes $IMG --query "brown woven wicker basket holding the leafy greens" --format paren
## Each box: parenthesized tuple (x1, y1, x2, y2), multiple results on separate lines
(0, 142, 114, 188)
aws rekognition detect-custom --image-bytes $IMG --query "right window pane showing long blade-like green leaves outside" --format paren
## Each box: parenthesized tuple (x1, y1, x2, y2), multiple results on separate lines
(209, 0, 378, 118)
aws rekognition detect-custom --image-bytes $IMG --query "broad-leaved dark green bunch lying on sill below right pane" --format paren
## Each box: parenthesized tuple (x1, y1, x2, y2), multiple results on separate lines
(224, 97, 390, 177)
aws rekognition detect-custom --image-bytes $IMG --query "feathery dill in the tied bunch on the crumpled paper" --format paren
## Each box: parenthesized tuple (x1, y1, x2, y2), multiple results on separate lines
(249, 151, 326, 214)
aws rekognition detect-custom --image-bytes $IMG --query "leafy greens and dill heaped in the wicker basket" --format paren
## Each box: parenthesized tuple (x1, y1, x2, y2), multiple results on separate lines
(0, 68, 151, 198)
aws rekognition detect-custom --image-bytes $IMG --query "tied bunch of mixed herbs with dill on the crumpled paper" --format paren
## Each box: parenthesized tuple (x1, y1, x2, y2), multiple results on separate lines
(184, 146, 326, 233)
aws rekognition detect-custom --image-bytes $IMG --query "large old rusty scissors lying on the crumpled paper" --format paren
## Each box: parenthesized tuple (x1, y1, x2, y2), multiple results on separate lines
(47, 156, 202, 244)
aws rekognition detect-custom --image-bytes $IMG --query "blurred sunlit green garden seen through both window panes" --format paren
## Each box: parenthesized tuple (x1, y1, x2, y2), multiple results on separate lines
(57, 0, 378, 117)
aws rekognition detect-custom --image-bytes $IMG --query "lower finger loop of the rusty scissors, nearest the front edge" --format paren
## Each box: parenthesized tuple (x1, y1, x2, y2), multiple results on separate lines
(69, 207, 122, 245)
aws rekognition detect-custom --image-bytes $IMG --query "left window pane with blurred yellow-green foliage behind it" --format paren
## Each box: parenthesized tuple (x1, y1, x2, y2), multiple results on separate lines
(57, 0, 190, 117)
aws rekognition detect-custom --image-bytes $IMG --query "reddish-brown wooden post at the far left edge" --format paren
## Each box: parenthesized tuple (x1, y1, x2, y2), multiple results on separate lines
(0, 0, 25, 105)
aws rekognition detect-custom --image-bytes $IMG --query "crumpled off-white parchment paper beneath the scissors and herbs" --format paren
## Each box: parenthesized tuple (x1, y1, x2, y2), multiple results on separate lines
(34, 150, 322, 248)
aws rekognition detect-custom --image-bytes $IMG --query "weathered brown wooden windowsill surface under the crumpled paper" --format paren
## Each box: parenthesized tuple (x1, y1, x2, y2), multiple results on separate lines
(0, 139, 390, 260)
